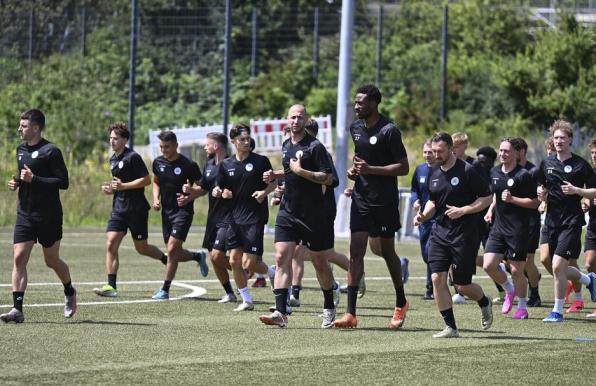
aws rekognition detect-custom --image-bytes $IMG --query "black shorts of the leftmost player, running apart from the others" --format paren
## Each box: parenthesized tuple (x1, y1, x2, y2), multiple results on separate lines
(13, 213, 62, 248)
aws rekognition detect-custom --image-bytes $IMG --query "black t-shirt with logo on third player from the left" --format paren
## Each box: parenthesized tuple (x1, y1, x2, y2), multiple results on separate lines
(153, 154, 201, 217)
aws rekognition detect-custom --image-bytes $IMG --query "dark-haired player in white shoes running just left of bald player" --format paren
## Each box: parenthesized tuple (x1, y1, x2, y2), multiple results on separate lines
(214, 124, 275, 311)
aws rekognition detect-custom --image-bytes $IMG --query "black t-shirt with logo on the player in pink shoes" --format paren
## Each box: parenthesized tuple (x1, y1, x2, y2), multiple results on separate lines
(490, 165, 536, 236)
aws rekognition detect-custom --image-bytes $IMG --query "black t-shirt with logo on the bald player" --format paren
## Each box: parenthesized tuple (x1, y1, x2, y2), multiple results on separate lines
(280, 134, 334, 223)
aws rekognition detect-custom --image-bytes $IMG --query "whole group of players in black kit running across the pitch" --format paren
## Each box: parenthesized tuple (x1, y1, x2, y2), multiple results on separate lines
(0, 85, 596, 338)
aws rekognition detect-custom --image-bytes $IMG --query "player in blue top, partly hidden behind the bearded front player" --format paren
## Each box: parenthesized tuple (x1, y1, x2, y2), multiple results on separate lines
(410, 139, 435, 300)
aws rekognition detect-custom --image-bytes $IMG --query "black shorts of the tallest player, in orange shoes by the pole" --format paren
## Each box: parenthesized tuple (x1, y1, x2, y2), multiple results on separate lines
(350, 200, 401, 238)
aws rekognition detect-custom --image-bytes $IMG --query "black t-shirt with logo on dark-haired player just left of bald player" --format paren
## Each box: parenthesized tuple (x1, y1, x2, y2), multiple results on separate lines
(217, 152, 272, 225)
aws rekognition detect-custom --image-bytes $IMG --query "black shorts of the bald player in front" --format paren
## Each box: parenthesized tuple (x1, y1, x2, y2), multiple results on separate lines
(275, 209, 335, 252)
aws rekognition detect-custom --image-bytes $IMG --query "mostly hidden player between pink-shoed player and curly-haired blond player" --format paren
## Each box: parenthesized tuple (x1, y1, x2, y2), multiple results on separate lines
(513, 137, 542, 307)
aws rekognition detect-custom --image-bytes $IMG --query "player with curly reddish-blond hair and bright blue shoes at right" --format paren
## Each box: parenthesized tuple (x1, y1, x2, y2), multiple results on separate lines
(537, 120, 596, 323)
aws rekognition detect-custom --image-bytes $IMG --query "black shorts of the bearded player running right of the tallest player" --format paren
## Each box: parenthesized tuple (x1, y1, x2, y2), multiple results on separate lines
(428, 232, 479, 285)
